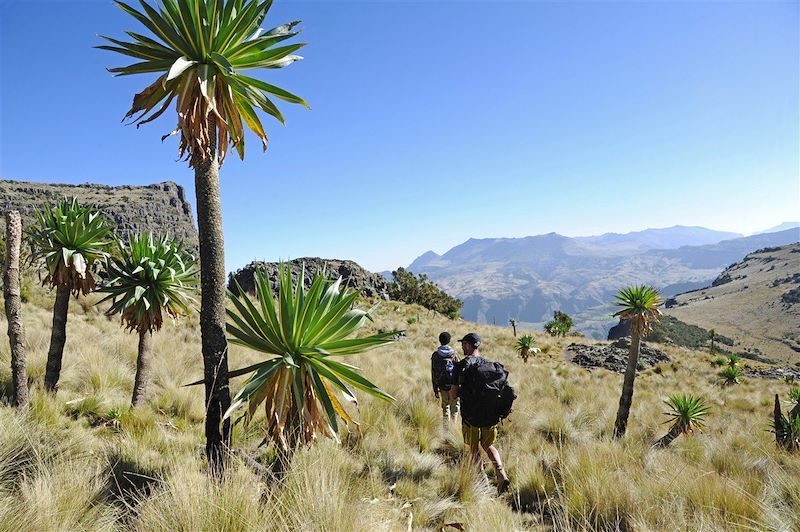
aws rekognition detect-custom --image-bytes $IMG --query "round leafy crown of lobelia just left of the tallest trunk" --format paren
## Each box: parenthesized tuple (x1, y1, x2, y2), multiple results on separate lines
(99, 233, 197, 332)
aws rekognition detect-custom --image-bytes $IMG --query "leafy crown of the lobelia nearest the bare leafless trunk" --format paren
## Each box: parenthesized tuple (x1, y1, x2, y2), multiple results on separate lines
(28, 197, 112, 296)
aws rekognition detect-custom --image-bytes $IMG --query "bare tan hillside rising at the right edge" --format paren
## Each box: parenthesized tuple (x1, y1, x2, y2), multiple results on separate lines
(666, 244, 800, 362)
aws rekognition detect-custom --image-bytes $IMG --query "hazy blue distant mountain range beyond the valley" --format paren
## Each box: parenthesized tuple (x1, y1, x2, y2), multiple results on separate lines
(408, 226, 800, 338)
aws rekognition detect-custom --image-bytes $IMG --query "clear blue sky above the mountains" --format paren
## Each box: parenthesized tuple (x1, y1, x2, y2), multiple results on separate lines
(0, 0, 800, 271)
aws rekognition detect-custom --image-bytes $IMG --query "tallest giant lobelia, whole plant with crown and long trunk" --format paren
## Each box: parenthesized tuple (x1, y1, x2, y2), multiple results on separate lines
(98, 0, 308, 474)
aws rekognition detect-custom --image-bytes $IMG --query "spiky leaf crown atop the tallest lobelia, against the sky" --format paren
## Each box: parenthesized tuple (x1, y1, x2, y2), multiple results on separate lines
(98, 0, 308, 166)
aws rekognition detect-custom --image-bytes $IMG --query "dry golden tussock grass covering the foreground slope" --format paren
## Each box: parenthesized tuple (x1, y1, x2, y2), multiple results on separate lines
(0, 291, 800, 530)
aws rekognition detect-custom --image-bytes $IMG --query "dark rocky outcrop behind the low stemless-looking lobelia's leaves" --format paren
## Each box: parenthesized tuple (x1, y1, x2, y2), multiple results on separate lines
(228, 257, 389, 299)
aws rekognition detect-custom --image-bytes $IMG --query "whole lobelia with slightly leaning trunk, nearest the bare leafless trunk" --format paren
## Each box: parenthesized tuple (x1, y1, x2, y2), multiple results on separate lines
(28, 197, 113, 394)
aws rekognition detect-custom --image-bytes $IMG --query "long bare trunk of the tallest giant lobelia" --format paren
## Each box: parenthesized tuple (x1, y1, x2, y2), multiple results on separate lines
(193, 115, 231, 476)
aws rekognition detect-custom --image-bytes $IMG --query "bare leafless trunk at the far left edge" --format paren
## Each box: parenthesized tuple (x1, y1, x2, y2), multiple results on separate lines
(3, 211, 28, 408)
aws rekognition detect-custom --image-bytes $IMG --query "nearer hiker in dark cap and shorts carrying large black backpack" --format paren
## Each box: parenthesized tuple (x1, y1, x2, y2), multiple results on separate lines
(452, 333, 515, 493)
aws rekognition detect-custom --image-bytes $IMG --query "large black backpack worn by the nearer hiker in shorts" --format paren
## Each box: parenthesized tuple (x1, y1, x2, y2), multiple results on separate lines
(459, 358, 517, 427)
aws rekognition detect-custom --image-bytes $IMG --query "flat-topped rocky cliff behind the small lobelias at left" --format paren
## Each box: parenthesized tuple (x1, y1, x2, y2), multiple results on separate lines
(0, 181, 198, 251)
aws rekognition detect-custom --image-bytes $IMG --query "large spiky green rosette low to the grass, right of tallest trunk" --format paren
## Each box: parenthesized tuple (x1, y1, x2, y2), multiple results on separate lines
(225, 267, 399, 447)
